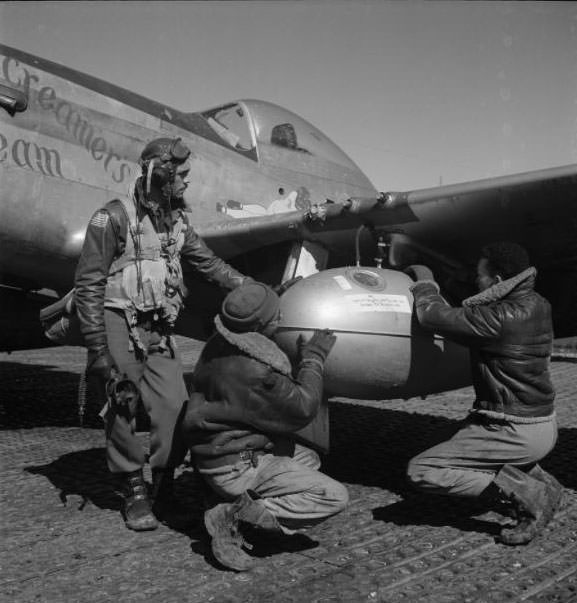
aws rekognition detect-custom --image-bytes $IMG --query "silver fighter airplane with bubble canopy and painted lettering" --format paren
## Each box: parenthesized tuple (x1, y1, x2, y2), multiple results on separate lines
(0, 45, 577, 406)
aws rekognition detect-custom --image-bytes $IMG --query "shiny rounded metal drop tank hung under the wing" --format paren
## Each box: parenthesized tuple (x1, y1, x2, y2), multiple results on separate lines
(275, 266, 471, 400)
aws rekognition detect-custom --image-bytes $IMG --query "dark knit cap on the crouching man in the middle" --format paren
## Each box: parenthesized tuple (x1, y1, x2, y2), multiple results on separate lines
(220, 282, 280, 333)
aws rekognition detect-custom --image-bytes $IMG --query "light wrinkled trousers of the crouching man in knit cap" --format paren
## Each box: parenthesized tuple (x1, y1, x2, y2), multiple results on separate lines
(200, 444, 349, 534)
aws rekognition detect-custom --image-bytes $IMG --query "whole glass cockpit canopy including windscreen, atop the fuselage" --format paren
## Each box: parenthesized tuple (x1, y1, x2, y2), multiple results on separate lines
(201, 100, 358, 171)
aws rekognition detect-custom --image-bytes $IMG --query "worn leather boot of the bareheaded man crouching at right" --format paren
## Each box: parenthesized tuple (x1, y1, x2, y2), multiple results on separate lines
(493, 465, 563, 546)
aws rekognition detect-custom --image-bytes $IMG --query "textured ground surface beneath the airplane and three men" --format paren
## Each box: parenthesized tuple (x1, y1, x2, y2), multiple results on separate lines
(0, 340, 577, 603)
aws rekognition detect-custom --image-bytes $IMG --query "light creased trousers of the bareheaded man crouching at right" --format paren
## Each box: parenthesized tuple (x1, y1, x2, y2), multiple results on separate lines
(407, 413, 557, 497)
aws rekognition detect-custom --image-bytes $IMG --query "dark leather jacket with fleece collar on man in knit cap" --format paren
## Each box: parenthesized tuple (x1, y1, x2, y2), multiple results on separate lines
(183, 318, 323, 469)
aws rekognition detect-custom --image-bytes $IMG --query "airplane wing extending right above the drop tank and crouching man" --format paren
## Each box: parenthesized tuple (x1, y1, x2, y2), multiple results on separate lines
(198, 164, 577, 336)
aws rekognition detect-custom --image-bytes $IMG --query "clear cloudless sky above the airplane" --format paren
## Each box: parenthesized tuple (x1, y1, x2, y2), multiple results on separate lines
(0, 0, 577, 190)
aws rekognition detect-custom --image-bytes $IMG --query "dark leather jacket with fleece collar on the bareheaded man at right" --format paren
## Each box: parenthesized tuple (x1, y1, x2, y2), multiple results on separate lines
(412, 268, 555, 423)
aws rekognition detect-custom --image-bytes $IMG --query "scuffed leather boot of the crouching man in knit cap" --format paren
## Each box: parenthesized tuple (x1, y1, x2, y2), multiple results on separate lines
(204, 491, 282, 572)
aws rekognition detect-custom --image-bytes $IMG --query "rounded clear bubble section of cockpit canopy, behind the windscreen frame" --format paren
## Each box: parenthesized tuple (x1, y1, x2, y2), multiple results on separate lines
(242, 100, 358, 170)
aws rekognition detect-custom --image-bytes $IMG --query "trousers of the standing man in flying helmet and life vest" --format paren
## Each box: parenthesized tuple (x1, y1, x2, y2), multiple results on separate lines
(102, 308, 188, 473)
